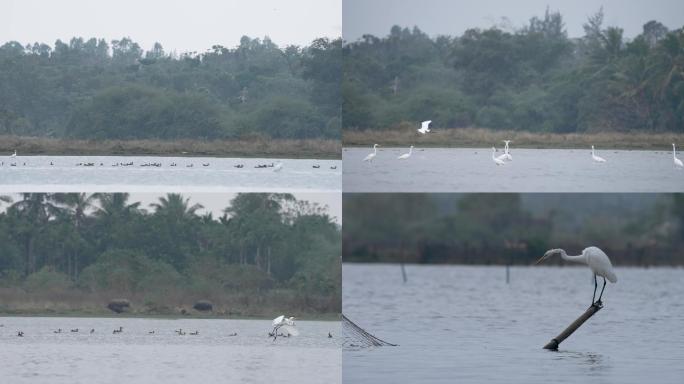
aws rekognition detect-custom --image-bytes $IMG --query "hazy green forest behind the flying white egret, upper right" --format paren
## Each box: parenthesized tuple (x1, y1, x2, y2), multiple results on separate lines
(342, 9, 684, 133)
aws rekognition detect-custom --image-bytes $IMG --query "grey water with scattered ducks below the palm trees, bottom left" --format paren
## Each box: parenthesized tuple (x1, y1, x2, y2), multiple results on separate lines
(0, 317, 342, 384)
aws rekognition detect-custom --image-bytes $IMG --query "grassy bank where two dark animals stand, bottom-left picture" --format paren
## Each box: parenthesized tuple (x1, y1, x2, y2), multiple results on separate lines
(0, 288, 339, 320)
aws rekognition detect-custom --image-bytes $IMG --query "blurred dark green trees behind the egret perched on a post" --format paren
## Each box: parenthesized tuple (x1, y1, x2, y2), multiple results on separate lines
(342, 194, 684, 266)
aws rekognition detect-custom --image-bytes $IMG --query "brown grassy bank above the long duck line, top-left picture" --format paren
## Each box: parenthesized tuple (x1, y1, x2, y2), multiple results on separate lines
(0, 136, 341, 159)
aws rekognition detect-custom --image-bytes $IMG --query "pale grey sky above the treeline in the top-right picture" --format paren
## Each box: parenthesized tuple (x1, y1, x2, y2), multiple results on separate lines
(342, 0, 684, 41)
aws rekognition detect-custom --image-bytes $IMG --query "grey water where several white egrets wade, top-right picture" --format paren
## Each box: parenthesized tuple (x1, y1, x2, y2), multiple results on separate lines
(342, 148, 684, 192)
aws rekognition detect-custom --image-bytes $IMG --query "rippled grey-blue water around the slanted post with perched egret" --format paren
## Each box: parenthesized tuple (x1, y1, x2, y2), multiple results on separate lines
(342, 264, 684, 384)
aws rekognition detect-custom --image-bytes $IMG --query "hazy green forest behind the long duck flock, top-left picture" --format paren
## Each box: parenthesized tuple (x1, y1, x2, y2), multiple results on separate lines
(0, 36, 342, 140)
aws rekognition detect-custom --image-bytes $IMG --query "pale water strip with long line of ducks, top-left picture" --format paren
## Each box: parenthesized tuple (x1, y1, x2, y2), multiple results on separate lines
(0, 156, 342, 193)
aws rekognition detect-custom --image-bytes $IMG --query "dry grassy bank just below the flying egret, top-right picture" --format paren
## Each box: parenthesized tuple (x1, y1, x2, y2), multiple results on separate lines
(343, 127, 684, 150)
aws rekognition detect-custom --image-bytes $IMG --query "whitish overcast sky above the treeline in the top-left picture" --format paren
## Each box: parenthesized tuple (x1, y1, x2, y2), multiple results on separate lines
(0, 0, 342, 53)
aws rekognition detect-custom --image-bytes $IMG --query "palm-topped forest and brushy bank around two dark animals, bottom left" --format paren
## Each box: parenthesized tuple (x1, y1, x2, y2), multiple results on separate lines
(0, 193, 341, 315)
